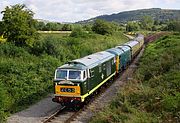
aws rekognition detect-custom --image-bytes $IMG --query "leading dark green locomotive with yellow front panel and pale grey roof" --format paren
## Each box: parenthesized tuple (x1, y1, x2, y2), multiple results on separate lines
(53, 51, 116, 105)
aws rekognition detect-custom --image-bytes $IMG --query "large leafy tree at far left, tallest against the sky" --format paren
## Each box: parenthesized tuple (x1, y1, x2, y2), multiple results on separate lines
(1, 4, 37, 46)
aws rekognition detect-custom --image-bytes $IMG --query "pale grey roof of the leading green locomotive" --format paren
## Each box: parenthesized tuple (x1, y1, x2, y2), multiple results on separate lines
(65, 51, 115, 69)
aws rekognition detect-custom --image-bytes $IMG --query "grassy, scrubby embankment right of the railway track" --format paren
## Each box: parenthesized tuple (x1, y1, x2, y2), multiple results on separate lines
(91, 33, 180, 123)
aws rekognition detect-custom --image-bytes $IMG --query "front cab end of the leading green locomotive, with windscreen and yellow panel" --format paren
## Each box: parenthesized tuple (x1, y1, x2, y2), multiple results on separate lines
(53, 63, 87, 105)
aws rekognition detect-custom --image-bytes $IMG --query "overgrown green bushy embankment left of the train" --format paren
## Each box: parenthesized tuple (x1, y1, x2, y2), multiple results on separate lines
(0, 33, 127, 122)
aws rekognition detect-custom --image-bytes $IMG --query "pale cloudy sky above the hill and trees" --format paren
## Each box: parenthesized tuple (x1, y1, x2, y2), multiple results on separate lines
(0, 0, 180, 22)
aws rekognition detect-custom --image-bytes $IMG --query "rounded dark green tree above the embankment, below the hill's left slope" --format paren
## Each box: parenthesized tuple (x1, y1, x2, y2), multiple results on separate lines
(92, 19, 114, 35)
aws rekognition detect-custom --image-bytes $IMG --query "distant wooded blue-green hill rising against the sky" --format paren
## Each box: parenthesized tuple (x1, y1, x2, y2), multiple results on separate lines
(78, 8, 180, 23)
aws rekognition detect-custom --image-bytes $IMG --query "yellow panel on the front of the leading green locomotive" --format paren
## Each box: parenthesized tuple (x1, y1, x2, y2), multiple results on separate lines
(55, 85, 81, 97)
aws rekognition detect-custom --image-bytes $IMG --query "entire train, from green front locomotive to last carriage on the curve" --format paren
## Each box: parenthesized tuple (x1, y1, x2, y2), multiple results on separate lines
(52, 34, 144, 106)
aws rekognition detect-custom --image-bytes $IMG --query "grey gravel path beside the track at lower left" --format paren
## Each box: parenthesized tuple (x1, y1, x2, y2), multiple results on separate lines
(7, 94, 60, 123)
